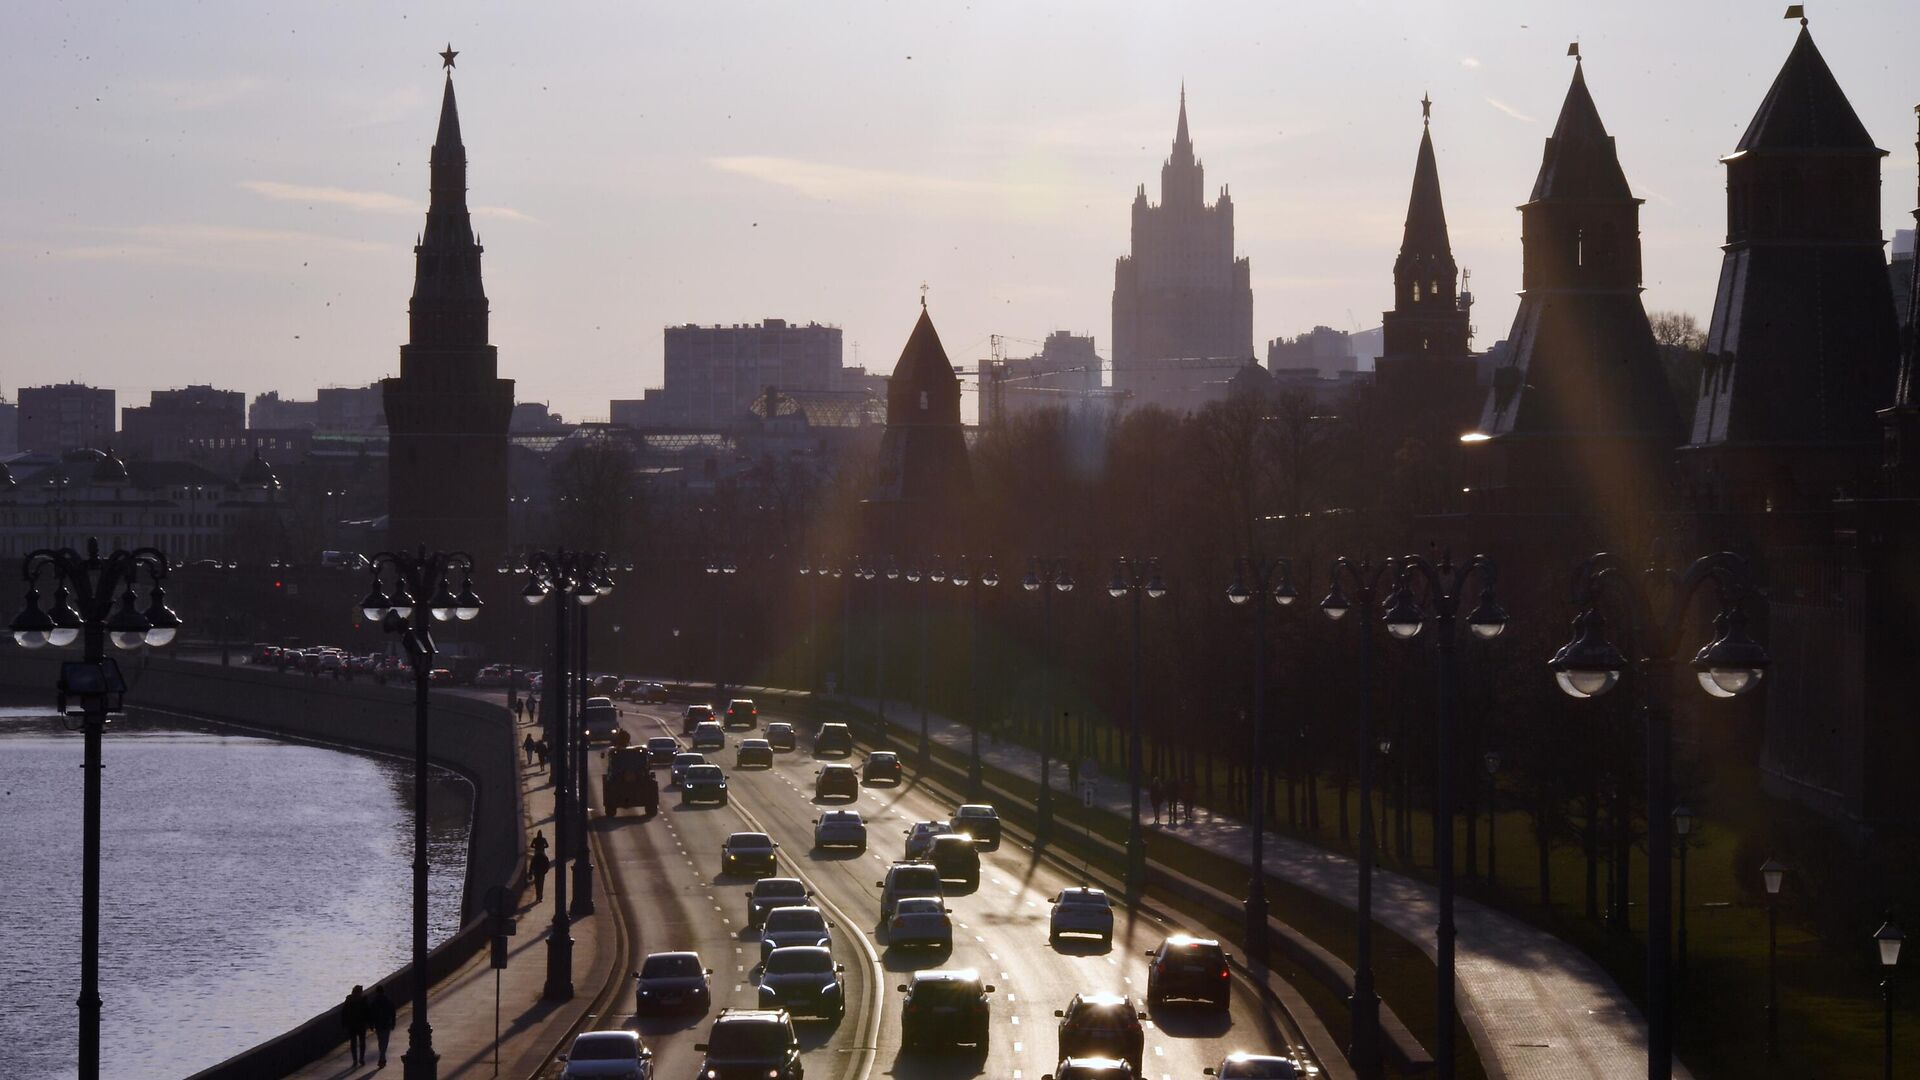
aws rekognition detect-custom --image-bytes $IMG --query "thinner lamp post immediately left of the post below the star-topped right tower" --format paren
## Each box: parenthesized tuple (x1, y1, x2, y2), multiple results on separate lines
(1321, 555, 1394, 1076)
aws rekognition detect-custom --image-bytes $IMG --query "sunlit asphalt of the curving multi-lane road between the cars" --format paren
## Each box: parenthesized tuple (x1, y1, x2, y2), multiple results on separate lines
(549, 705, 1306, 1080)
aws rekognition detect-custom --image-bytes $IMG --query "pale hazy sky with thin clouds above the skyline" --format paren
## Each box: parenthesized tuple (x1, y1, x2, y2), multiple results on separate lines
(0, 0, 1920, 417)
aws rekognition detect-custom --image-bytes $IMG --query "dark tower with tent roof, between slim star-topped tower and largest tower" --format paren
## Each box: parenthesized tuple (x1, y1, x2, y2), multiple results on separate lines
(1467, 60, 1682, 522)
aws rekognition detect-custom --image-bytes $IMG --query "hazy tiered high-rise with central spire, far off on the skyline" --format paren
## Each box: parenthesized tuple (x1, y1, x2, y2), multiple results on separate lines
(1114, 86, 1254, 411)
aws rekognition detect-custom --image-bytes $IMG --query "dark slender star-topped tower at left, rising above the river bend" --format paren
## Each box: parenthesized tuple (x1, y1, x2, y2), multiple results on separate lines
(382, 48, 513, 569)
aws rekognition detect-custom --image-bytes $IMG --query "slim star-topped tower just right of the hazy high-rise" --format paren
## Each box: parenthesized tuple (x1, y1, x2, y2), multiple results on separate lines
(1375, 98, 1480, 438)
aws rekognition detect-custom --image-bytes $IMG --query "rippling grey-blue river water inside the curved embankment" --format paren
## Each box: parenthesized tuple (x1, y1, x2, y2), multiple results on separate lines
(0, 709, 472, 1080)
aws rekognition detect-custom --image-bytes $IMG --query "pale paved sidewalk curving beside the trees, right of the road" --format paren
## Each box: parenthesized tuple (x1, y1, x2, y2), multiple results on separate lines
(825, 698, 1690, 1080)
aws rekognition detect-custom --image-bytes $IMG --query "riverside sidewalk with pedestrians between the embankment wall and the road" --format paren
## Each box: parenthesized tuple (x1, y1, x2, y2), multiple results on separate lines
(292, 694, 616, 1080)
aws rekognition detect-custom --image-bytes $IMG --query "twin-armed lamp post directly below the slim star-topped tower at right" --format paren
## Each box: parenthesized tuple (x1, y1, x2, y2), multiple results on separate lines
(1384, 555, 1507, 1080)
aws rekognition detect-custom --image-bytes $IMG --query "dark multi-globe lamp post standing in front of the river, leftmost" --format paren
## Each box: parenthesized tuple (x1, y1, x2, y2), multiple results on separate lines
(12, 538, 180, 1080)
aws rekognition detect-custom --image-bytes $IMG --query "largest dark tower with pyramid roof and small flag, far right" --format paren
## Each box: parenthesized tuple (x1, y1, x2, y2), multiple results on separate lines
(1682, 25, 1899, 511)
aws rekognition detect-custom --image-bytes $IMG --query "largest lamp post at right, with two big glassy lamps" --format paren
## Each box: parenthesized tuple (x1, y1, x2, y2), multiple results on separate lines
(1548, 552, 1770, 1080)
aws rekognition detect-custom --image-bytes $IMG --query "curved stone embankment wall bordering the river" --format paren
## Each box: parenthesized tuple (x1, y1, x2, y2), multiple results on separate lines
(0, 648, 526, 1080)
